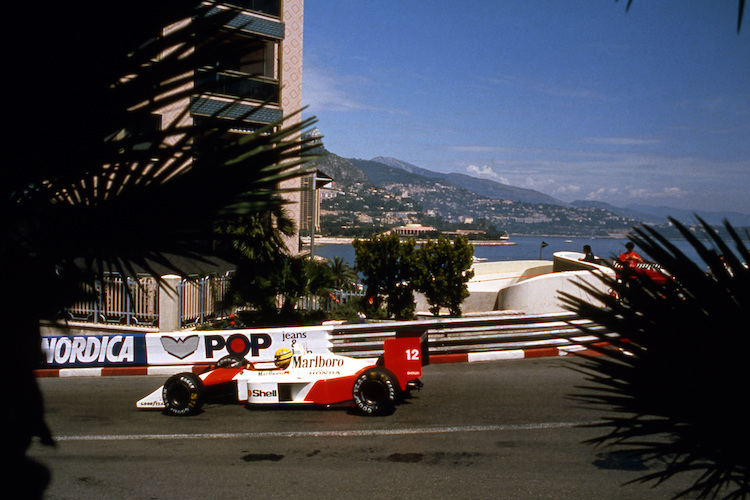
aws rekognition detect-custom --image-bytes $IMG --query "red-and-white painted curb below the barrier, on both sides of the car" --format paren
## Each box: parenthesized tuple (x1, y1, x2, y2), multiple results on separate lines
(34, 345, 596, 378)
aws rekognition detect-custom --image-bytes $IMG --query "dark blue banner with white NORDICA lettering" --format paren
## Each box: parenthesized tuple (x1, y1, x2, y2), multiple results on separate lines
(41, 333, 147, 368)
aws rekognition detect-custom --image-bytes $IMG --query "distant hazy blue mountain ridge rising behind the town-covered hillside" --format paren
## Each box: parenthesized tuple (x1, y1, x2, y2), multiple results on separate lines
(371, 156, 565, 205)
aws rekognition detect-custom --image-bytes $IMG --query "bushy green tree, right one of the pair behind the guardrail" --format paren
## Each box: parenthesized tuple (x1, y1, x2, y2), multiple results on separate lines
(414, 236, 474, 316)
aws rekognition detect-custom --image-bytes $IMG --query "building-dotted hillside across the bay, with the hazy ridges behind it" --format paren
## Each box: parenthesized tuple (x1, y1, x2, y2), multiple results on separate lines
(302, 139, 750, 237)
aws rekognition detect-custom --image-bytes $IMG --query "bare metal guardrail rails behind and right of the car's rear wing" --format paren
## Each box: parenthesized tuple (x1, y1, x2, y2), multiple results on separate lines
(331, 313, 607, 358)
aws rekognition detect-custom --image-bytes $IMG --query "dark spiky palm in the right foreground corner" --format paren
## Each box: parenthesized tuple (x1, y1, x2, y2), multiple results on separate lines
(565, 220, 750, 498)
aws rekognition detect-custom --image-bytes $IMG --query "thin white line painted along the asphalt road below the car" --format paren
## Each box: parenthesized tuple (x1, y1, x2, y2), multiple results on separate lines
(55, 422, 595, 442)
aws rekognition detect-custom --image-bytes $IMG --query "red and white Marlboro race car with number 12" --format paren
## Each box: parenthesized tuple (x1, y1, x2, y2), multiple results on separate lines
(136, 335, 429, 415)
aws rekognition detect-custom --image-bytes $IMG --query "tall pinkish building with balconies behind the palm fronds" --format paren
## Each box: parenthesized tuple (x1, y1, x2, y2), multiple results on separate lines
(161, 0, 304, 254)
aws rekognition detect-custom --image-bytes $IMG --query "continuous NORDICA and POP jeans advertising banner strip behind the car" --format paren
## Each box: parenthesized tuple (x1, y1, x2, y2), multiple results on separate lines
(42, 327, 331, 368)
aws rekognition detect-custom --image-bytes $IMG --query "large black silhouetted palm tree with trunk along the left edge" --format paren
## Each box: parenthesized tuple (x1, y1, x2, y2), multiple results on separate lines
(5, 0, 312, 492)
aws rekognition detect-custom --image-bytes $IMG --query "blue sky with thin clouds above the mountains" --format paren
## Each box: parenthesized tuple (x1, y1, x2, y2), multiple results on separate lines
(303, 0, 750, 213)
